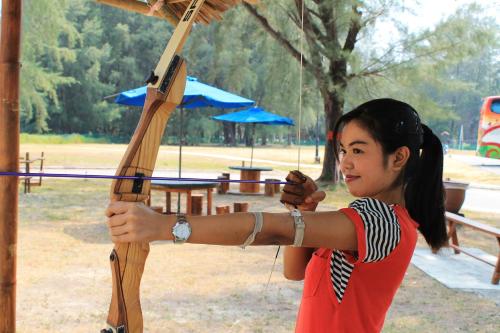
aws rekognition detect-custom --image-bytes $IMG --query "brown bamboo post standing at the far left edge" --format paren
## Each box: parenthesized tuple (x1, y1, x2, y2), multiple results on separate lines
(0, 0, 22, 333)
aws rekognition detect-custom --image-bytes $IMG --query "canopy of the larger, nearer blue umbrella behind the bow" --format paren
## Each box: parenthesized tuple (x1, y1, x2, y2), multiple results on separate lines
(115, 76, 255, 109)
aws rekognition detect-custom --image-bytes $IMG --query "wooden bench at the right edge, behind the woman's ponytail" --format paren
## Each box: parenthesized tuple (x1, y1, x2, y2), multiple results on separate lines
(446, 212, 500, 284)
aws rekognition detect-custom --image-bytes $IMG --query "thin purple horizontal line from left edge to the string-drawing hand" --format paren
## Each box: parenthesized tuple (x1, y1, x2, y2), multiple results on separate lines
(0, 171, 289, 184)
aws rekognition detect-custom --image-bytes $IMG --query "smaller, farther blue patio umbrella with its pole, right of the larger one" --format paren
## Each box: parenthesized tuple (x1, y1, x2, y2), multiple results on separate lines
(212, 107, 295, 166)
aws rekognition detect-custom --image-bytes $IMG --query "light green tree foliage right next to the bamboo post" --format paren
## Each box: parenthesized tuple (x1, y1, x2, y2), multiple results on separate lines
(21, 0, 78, 133)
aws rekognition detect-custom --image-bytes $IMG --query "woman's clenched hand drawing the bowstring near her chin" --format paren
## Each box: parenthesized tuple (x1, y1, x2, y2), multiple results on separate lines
(280, 170, 326, 211)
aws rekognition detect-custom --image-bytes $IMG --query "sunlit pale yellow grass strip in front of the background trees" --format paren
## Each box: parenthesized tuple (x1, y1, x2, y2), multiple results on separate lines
(21, 144, 500, 186)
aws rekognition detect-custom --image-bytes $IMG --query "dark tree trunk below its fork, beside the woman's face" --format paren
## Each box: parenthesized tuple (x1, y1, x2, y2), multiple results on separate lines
(318, 92, 344, 184)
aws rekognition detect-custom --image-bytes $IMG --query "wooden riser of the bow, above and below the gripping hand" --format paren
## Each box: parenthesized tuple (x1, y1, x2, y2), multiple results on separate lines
(107, 62, 187, 333)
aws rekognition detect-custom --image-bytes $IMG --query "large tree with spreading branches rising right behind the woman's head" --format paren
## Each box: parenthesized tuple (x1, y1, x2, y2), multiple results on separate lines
(244, 0, 496, 182)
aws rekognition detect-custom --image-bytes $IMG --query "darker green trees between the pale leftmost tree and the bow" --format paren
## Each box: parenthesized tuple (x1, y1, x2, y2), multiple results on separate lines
(50, 0, 169, 136)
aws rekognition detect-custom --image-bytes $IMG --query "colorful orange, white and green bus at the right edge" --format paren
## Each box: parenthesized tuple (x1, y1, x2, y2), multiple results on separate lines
(477, 96, 500, 159)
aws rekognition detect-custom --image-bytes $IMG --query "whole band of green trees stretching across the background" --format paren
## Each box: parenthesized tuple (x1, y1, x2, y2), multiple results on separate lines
(17, 0, 500, 150)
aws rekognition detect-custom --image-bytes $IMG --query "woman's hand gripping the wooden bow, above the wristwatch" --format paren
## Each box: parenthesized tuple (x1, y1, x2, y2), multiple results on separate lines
(106, 201, 168, 243)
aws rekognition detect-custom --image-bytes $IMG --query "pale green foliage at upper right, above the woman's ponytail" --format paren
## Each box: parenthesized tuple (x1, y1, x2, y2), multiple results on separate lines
(347, 0, 500, 139)
